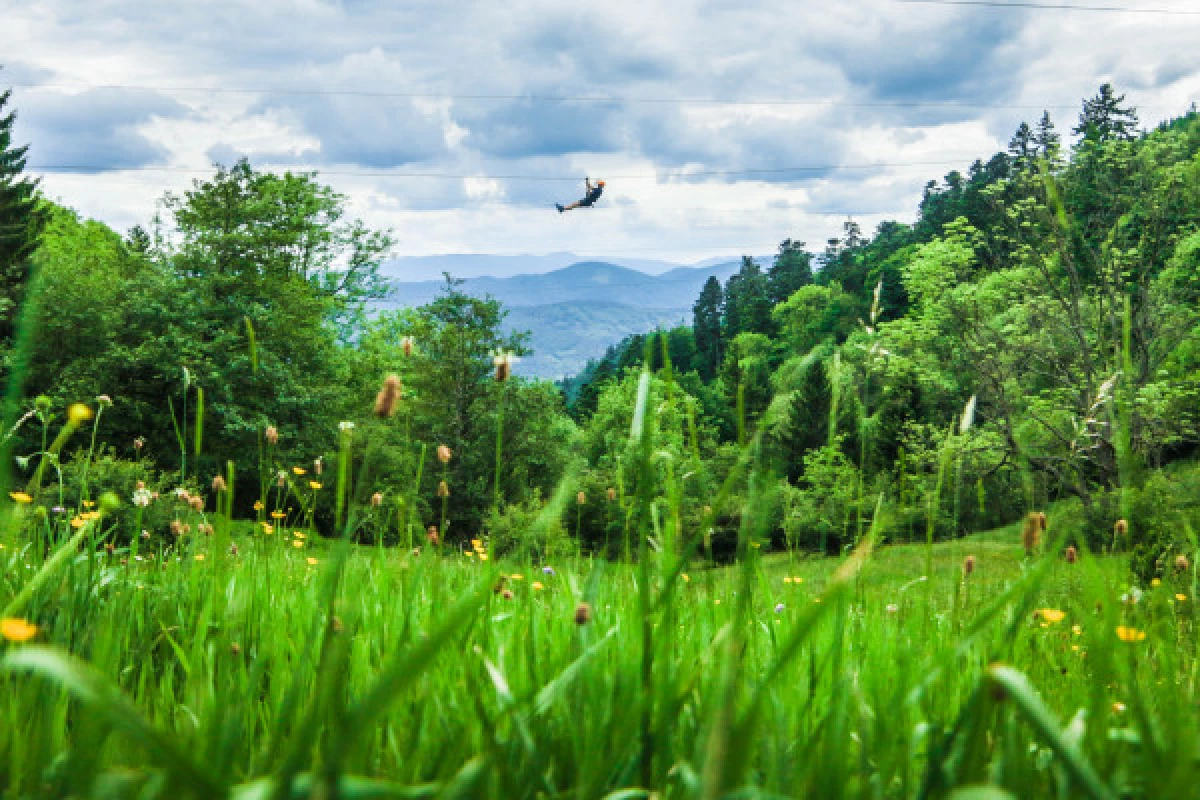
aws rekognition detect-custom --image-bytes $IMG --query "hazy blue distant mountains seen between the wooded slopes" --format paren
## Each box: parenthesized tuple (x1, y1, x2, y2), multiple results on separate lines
(380, 254, 767, 379)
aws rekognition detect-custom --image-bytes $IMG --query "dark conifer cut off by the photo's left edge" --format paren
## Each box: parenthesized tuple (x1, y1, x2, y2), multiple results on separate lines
(0, 90, 46, 343)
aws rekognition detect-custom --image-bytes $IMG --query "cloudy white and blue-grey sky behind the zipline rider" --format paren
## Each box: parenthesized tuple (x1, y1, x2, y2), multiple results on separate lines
(0, 0, 1200, 275)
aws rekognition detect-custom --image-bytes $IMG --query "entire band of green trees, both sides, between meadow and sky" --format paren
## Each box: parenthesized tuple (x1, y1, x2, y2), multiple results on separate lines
(0, 86, 1200, 568)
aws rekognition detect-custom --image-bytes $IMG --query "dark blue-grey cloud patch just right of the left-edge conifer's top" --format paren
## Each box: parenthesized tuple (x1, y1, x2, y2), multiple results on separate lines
(14, 89, 188, 172)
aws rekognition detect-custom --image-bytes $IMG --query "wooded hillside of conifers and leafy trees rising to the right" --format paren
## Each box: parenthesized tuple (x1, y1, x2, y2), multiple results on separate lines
(564, 85, 1200, 566)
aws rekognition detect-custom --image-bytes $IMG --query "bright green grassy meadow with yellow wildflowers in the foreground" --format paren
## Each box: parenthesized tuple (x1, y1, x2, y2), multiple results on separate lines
(0, 503, 1198, 798)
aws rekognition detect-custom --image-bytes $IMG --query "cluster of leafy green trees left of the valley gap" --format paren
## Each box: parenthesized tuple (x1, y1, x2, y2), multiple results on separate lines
(0, 87, 575, 543)
